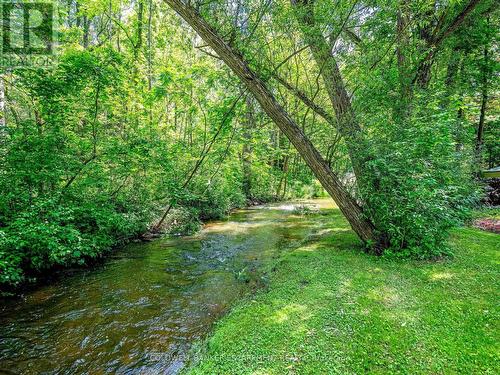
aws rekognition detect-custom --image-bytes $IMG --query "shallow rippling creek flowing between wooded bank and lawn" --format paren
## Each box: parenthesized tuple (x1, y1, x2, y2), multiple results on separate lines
(0, 200, 333, 374)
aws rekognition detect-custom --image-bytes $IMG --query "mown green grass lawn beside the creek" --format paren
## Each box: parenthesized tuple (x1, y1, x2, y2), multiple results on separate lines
(188, 211, 500, 374)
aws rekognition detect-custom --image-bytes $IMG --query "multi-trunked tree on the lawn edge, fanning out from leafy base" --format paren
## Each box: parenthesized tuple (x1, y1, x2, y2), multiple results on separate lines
(166, 0, 496, 253)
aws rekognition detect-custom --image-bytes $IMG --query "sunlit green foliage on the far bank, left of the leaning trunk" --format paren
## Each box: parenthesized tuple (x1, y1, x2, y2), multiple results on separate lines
(0, 2, 318, 285)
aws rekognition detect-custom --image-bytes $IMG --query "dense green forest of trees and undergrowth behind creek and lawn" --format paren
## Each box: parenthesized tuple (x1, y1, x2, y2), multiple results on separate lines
(0, 0, 500, 287)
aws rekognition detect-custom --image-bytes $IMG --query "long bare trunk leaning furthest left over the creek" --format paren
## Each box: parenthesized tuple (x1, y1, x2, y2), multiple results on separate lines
(165, 0, 379, 248)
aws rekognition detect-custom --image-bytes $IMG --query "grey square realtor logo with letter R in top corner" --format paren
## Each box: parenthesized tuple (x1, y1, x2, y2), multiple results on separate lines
(0, 1, 55, 67)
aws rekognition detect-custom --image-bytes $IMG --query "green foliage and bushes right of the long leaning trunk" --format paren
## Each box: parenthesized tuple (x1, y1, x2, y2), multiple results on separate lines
(186, 0, 498, 258)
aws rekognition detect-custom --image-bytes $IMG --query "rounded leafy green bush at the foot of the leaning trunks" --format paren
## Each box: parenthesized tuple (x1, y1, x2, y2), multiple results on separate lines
(362, 104, 478, 258)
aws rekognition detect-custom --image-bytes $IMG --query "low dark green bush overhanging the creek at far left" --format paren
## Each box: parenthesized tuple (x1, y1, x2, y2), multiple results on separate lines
(0, 200, 143, 286)
